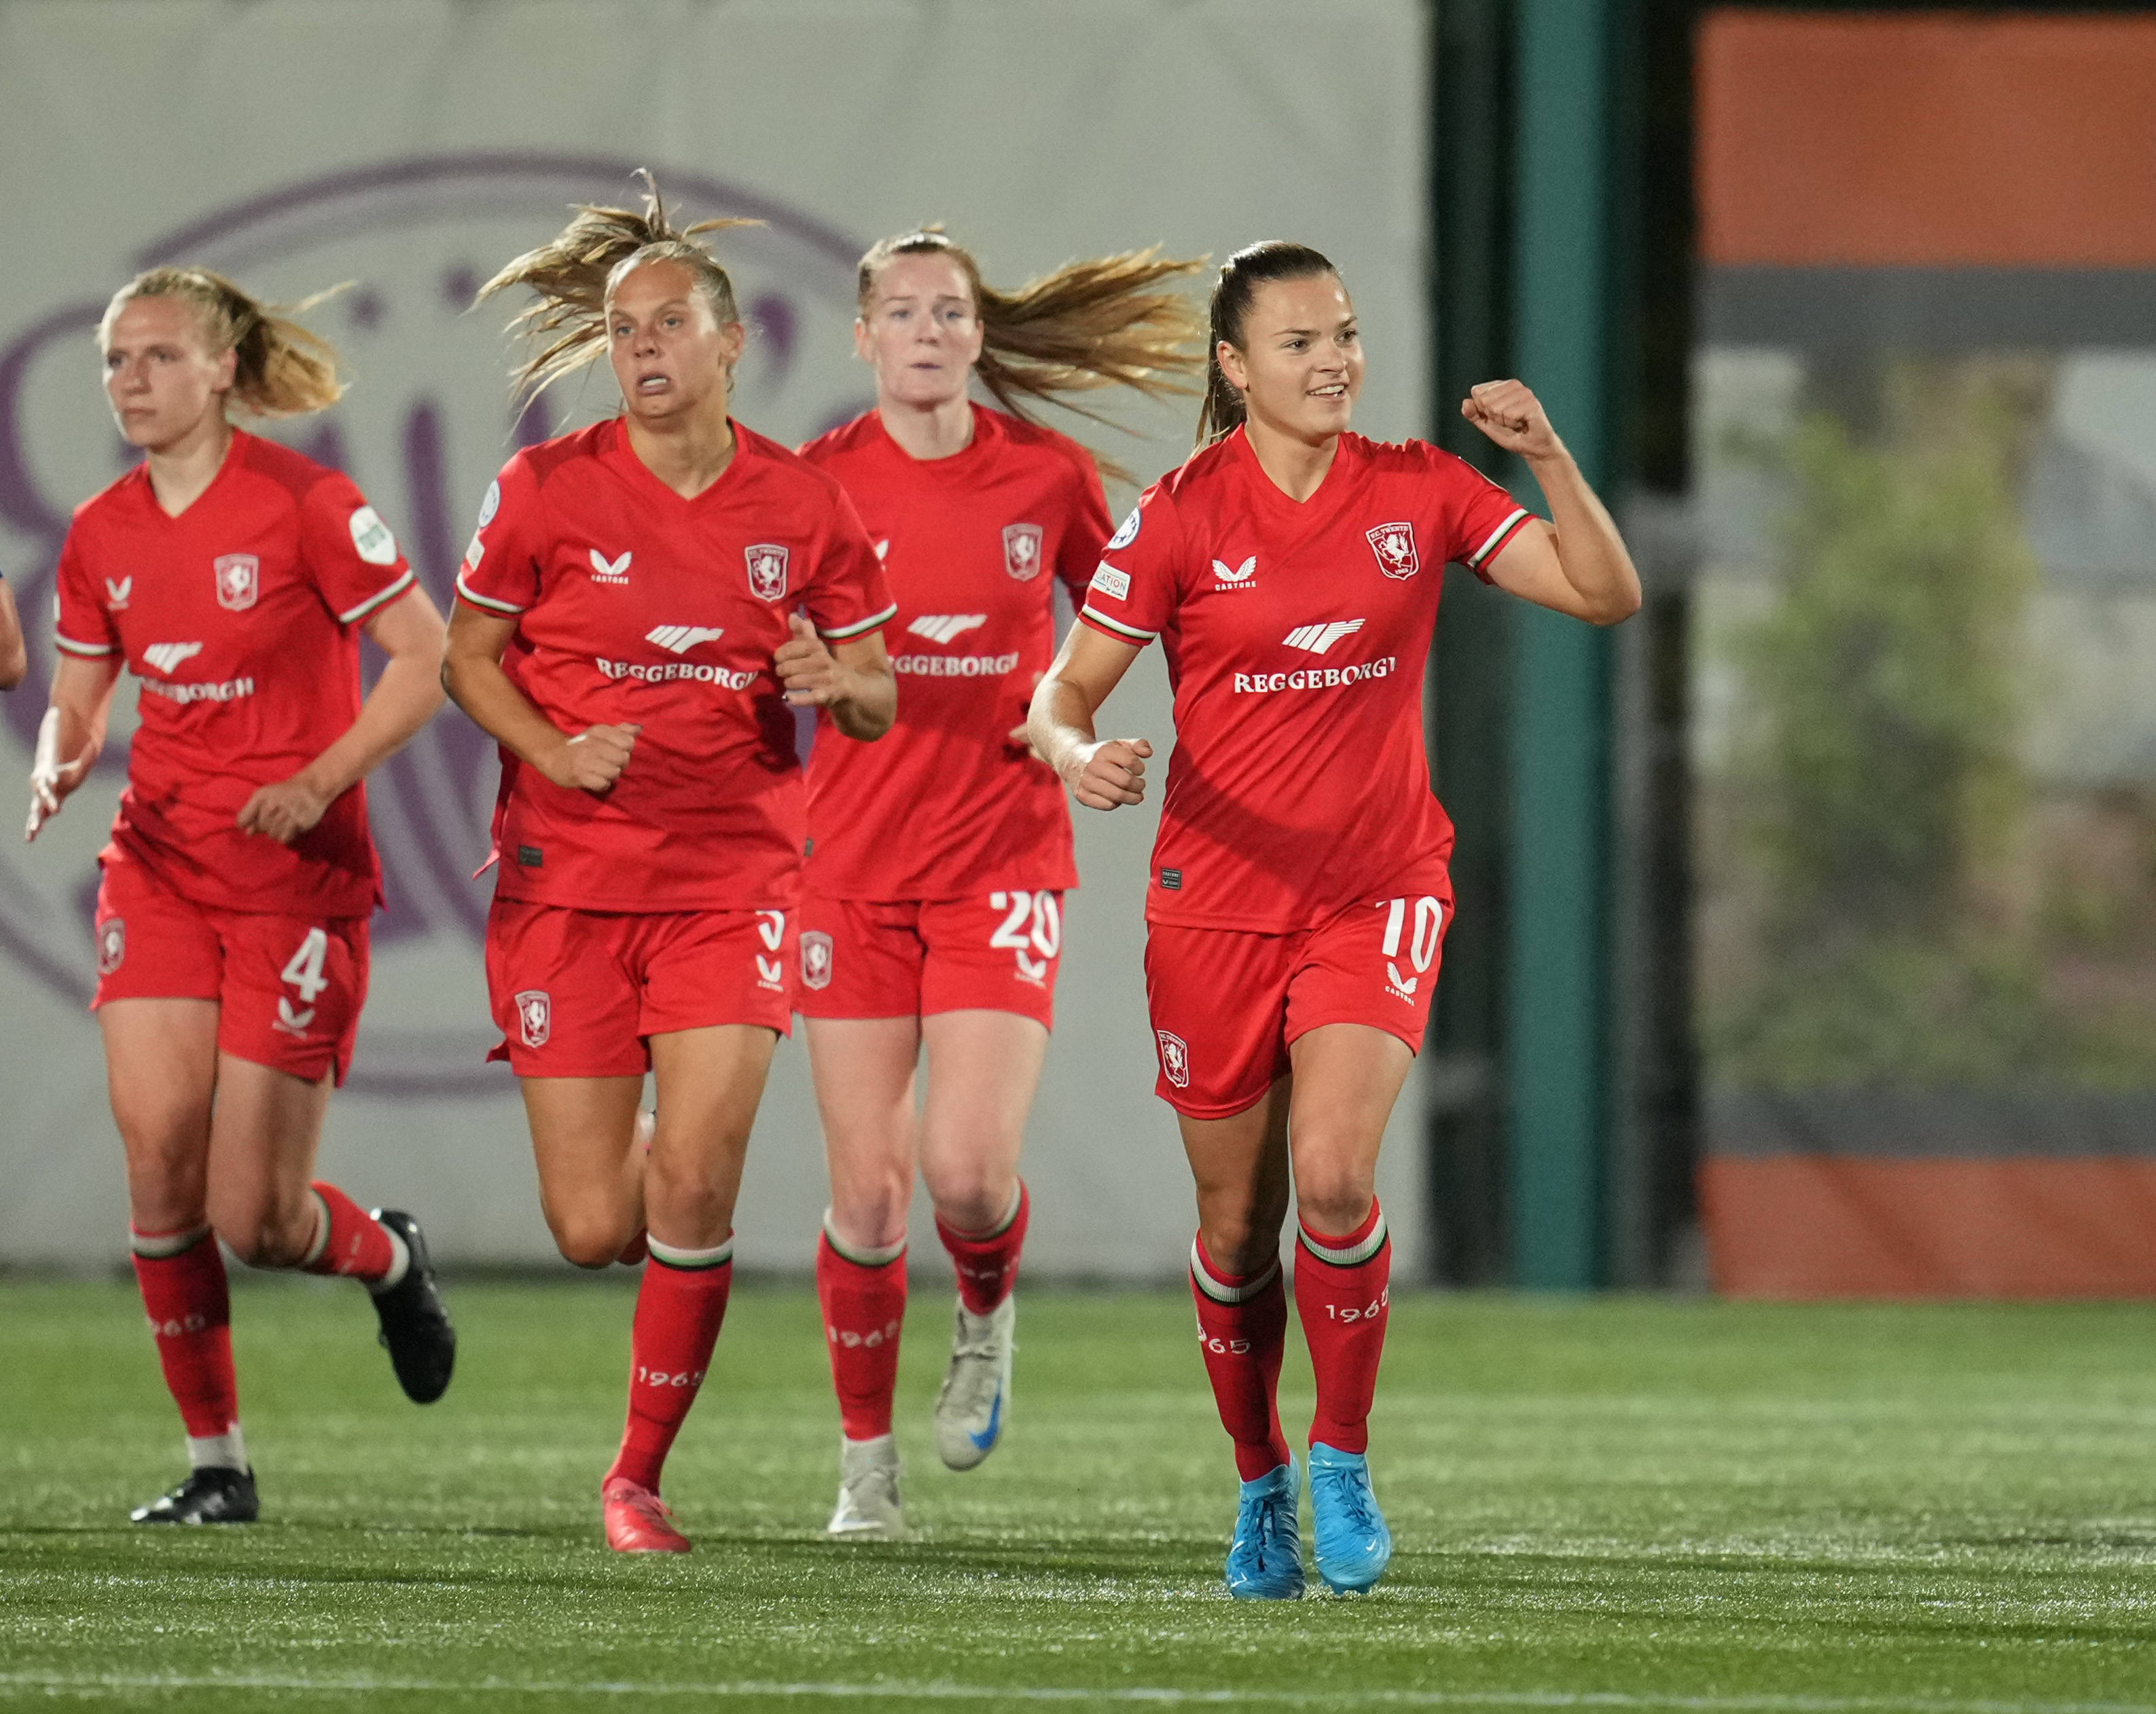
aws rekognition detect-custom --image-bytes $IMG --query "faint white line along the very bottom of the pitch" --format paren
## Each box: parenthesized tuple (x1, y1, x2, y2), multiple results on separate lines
(0, 1673, 2156, 1714)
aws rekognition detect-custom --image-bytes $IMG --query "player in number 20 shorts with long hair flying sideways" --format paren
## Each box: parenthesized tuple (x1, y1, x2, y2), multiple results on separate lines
(795, 229, 1197, 1537)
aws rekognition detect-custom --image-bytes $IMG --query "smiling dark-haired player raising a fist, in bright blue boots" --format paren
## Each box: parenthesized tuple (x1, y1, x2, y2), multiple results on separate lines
(1030, 244, 1638, 1598)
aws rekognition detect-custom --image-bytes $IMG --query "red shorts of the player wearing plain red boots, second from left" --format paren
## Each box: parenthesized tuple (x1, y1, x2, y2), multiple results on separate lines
(487, 899, 793, 1078)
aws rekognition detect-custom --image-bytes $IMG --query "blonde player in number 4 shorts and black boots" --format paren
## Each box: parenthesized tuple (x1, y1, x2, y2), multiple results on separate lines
(26, 268, 457, 1525)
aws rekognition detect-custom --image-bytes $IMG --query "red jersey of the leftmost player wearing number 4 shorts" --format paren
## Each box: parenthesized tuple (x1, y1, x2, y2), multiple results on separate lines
(54, 431, 412, 916)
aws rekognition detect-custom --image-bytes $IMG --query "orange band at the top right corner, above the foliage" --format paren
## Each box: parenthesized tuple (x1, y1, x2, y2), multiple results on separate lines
(1699, 11, 2156, 268)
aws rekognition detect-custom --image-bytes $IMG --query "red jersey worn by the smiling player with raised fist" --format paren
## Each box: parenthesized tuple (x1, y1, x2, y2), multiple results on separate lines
(1080, 429, 1528, 934)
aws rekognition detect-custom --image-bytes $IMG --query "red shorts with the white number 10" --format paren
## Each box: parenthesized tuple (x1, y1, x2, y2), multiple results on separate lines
(1145, 890, 1453, 1119)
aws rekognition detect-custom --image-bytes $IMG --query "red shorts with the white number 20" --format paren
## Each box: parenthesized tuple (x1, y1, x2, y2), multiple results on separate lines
(793, 888, 1063, 1028)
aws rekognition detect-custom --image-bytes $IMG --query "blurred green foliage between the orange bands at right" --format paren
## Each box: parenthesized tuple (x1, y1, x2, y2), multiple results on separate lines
(1703, 360, 2156, 1089)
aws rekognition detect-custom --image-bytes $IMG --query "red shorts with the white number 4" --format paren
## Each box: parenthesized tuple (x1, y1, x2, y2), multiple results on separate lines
(90, 858, 367, 1082)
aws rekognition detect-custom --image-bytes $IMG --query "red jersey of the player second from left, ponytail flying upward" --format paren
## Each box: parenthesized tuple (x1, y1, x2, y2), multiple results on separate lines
(457, 418, 893, 912)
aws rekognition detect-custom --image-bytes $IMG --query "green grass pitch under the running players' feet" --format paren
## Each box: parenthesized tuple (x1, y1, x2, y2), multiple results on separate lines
(0, 1279, 2156, 1714)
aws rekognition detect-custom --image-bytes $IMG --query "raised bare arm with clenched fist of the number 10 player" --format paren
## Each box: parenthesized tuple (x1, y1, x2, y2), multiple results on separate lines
(1460, 382, 1640, 625)
